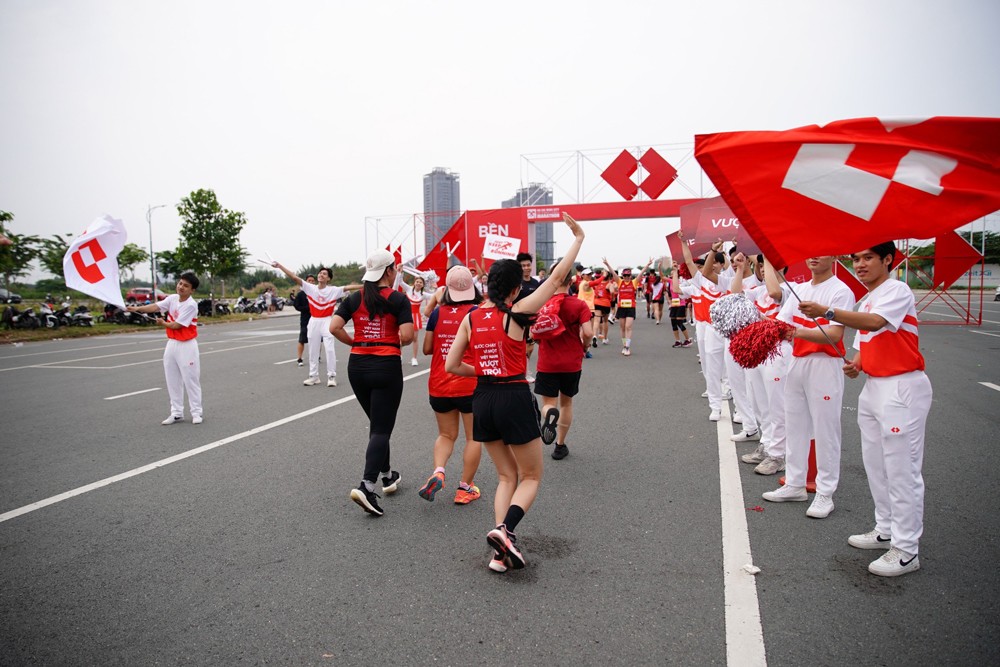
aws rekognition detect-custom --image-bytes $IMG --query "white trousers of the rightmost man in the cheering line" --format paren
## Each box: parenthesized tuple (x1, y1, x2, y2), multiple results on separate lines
(858, 371, 933, 555)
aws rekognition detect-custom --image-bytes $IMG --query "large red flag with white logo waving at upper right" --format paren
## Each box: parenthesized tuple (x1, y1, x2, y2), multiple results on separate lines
(695, 117, 1000, 268)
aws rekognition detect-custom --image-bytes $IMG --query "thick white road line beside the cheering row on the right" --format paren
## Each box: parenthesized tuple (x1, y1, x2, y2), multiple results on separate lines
(718, 401, 767, 666)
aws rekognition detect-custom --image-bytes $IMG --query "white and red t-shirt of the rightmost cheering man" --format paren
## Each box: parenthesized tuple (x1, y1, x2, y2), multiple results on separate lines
(854, 278, 925, 377)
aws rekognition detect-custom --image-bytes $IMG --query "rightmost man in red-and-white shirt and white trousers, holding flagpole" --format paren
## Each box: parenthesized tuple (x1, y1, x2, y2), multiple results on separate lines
(799, 241, 933, 577)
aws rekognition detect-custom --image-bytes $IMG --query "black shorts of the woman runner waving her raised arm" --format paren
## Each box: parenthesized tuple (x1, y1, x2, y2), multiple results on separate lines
(472, 382, 542, 445)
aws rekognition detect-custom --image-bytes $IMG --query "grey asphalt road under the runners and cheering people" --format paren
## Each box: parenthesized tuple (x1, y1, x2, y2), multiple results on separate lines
(0, 302, 1000, 665)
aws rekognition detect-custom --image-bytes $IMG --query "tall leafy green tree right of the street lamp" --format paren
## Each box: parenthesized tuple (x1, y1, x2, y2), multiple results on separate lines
(177, 190, 247, 291)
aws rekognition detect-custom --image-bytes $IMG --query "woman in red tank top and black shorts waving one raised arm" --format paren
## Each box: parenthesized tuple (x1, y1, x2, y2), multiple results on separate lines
(445, 213, 584, 572)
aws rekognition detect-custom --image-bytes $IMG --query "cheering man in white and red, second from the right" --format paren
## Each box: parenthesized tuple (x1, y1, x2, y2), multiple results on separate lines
(763, 255, 854, 519)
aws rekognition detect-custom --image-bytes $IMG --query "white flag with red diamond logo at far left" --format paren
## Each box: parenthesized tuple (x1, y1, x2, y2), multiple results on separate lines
(63, 215, 128, 308)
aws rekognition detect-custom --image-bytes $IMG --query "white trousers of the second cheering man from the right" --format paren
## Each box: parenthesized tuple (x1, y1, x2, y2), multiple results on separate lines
(785, 352, 844, 496)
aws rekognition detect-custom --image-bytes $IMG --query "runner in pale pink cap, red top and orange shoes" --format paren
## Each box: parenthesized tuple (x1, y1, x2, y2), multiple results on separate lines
(418, 266, 483, 505)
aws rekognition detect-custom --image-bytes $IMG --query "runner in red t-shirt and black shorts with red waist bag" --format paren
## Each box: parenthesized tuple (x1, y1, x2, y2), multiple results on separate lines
(535, 266, 594, 461)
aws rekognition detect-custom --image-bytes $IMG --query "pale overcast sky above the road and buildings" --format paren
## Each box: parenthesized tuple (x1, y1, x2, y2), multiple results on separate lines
(0, 0, 1000, 277)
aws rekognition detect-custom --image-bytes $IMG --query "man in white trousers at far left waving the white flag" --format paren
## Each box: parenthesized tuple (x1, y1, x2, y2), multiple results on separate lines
(126, 271, 202, 426)
